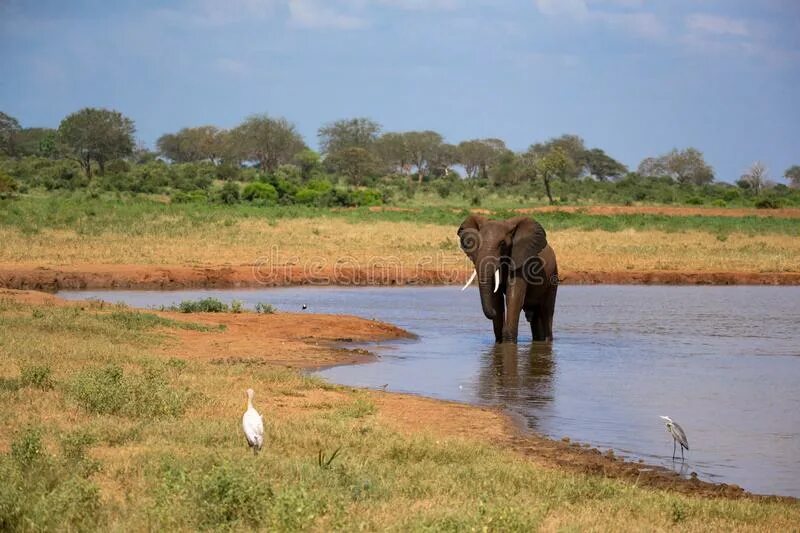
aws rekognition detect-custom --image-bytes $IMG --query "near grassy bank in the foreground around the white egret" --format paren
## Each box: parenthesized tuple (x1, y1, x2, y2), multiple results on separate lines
(0, 298, 800, 531)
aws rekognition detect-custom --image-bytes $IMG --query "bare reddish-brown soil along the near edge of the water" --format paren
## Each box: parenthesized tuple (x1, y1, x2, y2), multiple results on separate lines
(0, 289, 797, 502)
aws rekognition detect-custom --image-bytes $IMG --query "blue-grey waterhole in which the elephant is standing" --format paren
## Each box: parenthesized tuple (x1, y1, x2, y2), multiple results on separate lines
(61, 286, 800, 496)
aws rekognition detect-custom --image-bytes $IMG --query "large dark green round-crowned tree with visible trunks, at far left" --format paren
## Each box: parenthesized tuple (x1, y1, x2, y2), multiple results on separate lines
(58, 107, 136, 178)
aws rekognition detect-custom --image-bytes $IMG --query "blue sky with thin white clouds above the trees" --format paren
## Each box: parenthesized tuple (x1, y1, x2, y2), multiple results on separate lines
(0, 0, 800, 181)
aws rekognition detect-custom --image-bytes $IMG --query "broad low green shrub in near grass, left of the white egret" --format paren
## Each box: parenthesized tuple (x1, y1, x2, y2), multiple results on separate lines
(68, 365, 188, 418)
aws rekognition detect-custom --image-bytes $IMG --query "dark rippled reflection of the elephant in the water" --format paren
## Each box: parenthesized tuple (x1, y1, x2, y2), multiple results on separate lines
(478, 343, 555, 405)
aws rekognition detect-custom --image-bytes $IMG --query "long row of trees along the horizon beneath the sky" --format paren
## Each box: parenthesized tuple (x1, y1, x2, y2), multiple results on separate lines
(0, 108, 800, 203)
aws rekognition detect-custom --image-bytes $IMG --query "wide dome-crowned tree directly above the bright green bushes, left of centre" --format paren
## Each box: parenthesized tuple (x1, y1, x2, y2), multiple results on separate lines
(230, 115, 306, 172)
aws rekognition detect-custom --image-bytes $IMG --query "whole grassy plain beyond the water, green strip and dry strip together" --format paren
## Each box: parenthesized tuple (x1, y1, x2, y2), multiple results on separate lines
(0, 192, 800, 272)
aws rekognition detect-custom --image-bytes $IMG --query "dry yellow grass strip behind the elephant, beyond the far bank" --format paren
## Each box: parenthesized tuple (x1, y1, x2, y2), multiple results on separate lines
(0, 218, 800, 272)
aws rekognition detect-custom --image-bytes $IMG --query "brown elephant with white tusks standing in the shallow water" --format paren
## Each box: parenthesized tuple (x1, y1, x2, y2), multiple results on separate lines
(458, 215, 558, 343)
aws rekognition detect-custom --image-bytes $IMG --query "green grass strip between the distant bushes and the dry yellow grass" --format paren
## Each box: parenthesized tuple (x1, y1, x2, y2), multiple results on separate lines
(0, 193, 800, 238)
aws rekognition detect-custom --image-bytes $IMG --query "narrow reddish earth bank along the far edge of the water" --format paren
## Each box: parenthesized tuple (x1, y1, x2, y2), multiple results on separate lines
(0, 265, 800, 292)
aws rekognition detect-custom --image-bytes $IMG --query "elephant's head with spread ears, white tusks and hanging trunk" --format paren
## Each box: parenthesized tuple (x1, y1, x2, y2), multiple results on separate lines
(458, 215, 547, 319)
